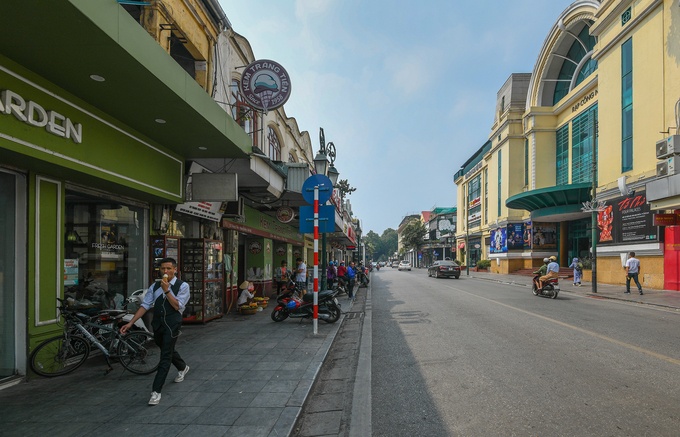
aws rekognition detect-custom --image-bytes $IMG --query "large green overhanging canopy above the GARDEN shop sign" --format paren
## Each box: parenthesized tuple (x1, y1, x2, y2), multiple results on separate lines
(0, 0, 252, 159)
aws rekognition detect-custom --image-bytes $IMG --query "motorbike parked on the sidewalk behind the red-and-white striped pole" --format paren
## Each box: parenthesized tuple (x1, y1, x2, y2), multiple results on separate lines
(271, 282, 342, 323)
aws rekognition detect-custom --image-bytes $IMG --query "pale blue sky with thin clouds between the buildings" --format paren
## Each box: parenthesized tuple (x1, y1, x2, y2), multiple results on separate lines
(220, 0, 572, 235)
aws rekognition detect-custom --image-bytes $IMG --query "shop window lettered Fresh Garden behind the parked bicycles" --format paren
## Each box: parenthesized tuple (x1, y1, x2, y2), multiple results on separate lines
(64, 191, 148, 308)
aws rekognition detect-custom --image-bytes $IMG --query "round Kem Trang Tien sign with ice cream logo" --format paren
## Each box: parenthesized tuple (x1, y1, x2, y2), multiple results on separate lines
(239, 59, 290, 112)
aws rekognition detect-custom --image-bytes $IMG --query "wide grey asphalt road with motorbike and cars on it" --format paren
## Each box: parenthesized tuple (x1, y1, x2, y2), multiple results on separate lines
(372, 269, 680, 437)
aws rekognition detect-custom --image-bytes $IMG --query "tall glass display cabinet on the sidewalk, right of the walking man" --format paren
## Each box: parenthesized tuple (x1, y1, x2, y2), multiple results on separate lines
(180, 238, 224, 323)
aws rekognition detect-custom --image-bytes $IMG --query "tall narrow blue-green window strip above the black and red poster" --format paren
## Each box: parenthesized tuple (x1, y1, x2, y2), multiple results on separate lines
(621, 39, 633, 172)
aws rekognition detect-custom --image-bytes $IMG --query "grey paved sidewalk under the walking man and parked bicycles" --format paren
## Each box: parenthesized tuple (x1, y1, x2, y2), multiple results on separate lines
(0, 290, 362, 437)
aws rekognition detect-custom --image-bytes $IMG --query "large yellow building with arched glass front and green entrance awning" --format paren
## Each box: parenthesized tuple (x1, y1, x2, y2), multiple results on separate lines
(454, 0, 680, 288)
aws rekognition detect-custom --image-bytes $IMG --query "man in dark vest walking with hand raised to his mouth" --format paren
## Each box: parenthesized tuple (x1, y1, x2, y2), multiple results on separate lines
(120, 258, 190, 405)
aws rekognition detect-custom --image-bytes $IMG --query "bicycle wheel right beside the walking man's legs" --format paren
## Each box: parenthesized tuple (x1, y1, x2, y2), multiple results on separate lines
(118, 331, 161, 375)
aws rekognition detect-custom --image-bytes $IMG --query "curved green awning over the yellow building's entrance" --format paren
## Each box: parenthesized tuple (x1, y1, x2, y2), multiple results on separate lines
(505, 182, 592, 213)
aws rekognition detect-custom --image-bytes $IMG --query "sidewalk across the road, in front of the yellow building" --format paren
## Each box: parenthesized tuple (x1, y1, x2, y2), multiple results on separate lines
(462, 271, 680, 310)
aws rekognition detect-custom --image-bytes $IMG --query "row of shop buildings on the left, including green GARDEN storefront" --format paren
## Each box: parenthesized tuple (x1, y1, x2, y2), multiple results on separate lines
(0, 0, 355, 383)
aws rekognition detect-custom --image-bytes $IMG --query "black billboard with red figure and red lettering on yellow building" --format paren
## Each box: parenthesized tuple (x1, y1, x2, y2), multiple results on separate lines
(597, 193, 659, 244)
